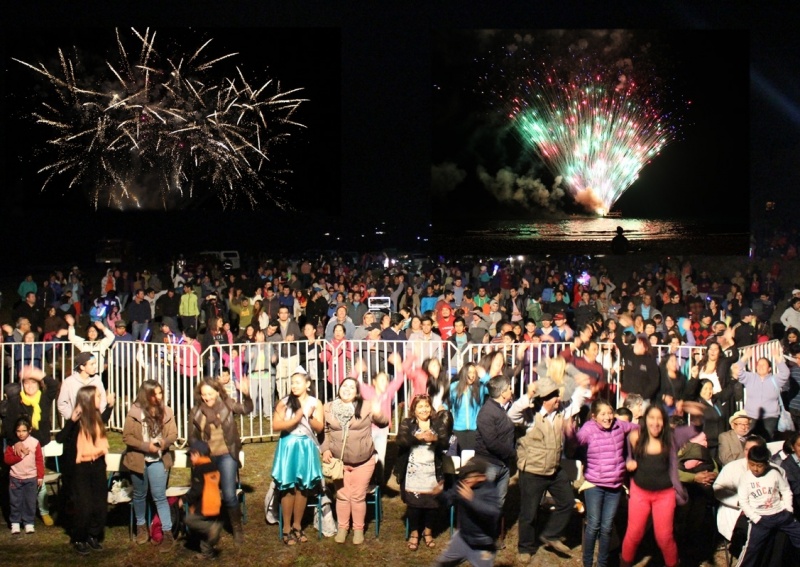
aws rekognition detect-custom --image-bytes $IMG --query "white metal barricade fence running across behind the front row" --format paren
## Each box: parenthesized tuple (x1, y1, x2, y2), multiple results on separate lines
(0, 339, 779, 444)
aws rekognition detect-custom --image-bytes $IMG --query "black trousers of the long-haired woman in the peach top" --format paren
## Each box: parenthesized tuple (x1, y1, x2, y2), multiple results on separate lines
(71, 457, 108, 541)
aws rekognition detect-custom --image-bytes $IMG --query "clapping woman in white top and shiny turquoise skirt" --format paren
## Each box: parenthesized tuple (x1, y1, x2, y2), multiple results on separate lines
(272, 367, 325, 545)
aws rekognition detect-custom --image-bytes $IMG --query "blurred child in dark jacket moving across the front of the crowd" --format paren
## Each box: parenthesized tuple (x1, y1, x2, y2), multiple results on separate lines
(436, 457, 502, 567)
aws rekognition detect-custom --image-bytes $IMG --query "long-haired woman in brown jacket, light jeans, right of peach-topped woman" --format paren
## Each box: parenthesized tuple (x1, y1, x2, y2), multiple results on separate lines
(122, 380, 178, 553)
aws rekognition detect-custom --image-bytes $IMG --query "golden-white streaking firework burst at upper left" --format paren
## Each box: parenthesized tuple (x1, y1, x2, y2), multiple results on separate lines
(15, 29, 307, 209)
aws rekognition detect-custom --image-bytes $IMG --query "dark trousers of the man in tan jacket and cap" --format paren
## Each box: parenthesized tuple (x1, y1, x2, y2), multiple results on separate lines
(518, 468, 575, 553)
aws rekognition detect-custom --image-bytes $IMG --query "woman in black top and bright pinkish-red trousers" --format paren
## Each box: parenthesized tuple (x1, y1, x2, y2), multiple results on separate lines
(619, 401, 703, 567)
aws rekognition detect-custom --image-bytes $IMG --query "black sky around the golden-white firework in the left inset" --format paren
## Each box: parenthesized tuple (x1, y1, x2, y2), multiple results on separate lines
(3, 25, 341, 214)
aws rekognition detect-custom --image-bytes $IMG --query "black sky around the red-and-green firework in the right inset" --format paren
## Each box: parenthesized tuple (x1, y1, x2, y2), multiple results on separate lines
(433, 30, 749, 224)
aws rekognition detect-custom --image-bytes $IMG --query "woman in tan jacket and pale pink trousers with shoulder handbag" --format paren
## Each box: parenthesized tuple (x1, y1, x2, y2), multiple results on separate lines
(321, 378, 389, 545)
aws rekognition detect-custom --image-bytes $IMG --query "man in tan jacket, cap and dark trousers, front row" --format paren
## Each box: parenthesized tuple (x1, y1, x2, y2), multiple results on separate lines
(517, 377, 575, 565)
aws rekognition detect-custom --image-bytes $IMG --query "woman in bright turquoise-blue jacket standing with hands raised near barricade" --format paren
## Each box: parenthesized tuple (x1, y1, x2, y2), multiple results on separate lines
(448, 362, 491, 451)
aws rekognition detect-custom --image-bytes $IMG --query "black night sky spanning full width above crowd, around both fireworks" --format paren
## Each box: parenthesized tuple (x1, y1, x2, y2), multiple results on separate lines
(0, 0, 800, 266)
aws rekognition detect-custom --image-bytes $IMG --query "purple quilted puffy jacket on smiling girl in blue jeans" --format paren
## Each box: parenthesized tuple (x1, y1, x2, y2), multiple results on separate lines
(578, 419, 639, 488)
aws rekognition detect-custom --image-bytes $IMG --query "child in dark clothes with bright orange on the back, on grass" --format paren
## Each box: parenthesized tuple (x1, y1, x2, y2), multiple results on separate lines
(178, 439, 222, 559)
